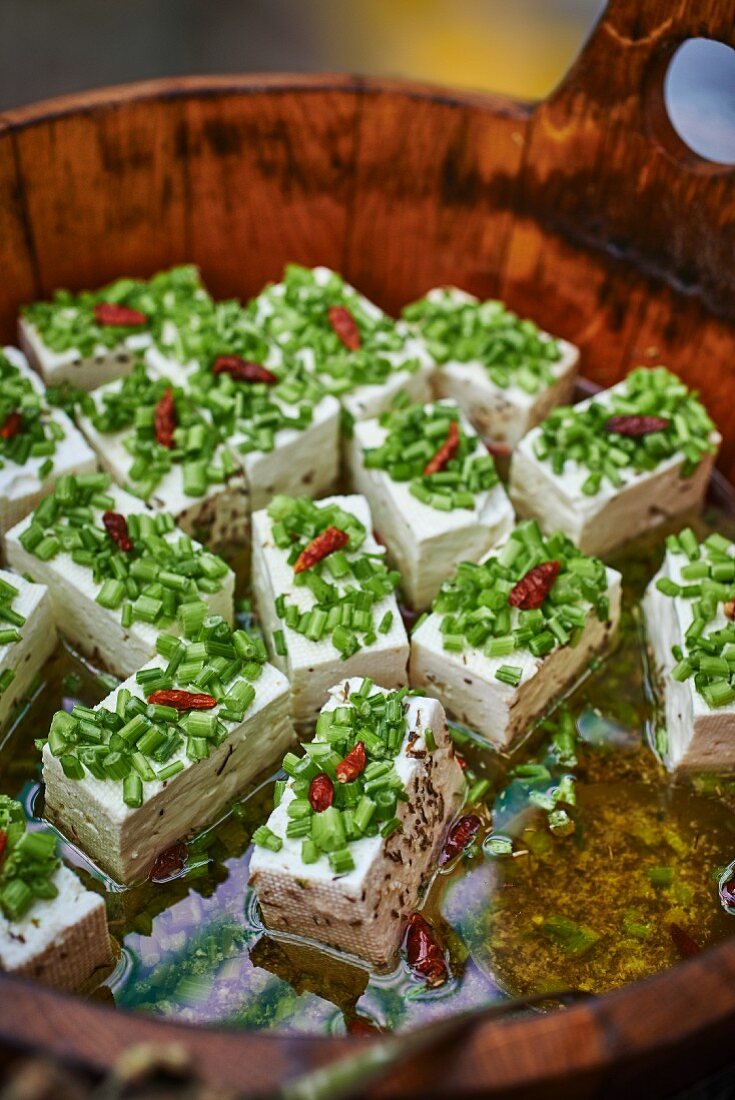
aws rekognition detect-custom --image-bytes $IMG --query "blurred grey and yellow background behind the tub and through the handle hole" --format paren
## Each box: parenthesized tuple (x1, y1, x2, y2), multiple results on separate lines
(0, 0, 735, 165)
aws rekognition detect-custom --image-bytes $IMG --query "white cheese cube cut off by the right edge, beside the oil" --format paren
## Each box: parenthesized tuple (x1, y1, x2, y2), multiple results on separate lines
(643, 547, 735, 772)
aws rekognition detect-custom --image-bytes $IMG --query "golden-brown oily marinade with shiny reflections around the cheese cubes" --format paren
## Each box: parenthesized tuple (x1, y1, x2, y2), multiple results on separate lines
(0, 509, 735, 1034)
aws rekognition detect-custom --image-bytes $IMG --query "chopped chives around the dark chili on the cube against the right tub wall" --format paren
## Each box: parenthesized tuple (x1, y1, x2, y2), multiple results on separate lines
(534, 366, 716, 496)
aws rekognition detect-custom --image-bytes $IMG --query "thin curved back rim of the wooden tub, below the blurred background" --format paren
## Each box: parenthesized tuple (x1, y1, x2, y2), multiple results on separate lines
(0, 73, 536, 130)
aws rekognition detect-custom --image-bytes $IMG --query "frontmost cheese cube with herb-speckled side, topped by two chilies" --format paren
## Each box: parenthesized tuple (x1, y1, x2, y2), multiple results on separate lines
(250, 679, 465, 967)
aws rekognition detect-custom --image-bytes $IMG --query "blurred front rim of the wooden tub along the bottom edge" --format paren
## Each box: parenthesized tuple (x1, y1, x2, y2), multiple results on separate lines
(0, 928, 735, 1100)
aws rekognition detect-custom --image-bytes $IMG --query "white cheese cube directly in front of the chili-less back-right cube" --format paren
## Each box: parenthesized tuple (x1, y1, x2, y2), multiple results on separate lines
(349, 403, 514, 611)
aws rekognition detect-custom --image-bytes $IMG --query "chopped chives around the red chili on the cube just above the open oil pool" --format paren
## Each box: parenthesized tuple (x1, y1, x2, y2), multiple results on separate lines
(432, 519, 610, 655)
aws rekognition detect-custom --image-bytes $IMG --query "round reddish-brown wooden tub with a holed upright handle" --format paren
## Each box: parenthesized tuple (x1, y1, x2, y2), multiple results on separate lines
(0, 0, 735, 1100)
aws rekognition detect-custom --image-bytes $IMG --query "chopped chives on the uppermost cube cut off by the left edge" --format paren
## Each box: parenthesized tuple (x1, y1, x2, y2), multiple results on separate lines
(0, 350, 65, 474)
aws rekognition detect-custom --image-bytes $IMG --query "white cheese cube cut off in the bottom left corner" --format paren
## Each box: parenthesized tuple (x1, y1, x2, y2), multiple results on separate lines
(0, 867, 112, 991)
